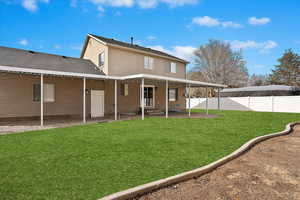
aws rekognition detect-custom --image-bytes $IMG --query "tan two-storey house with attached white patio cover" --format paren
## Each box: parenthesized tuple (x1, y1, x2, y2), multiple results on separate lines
(0, 34, 226, 125)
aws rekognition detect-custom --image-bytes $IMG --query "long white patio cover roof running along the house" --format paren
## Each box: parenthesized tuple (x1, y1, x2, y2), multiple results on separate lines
(0, 65, 227, 88)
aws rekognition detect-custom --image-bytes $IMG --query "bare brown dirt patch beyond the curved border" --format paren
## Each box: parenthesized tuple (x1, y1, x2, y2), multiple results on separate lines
(137, 126, 300, 200)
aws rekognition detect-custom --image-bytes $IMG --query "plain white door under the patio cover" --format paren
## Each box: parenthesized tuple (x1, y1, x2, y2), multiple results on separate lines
(91, 90, 104, 118)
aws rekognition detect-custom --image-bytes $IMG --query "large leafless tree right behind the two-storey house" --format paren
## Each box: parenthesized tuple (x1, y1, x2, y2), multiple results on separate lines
(192, 40, 248, 87)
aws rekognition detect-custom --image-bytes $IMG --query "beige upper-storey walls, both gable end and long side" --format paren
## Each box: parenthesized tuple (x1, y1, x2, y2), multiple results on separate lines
(83, 38, 186, 79)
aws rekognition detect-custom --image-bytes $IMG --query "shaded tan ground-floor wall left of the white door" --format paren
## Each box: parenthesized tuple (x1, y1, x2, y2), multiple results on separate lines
(0, 73, 104, 118)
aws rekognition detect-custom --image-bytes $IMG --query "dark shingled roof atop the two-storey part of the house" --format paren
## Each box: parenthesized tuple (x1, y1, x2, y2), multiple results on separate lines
(84, 34, 189, 63)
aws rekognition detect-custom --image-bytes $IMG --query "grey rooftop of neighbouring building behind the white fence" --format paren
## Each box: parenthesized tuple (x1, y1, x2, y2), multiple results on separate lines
(222, 85, 300, 92)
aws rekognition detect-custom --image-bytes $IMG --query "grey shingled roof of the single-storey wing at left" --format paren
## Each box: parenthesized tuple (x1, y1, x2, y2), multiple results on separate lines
(0, 46, 104, 75)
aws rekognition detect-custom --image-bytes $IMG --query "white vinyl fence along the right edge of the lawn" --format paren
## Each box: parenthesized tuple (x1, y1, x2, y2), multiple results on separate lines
(186, 96, 300, 113)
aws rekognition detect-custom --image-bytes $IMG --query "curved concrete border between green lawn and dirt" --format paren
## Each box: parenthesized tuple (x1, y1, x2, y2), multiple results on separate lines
(99, 122, 300, 200)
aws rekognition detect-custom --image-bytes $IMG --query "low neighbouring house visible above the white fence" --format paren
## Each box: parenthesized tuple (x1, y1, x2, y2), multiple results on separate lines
(221, 85, 300, 97)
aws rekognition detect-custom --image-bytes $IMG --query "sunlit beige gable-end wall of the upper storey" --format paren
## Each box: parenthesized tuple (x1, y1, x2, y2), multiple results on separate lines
(83, 38, 108, 74)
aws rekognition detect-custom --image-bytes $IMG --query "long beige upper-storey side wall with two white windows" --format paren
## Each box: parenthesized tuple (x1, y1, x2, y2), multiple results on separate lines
(108, 47, 186, 79)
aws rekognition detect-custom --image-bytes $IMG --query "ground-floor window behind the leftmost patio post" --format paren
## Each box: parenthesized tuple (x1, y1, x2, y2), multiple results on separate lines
(33, 84, 55, 102)
